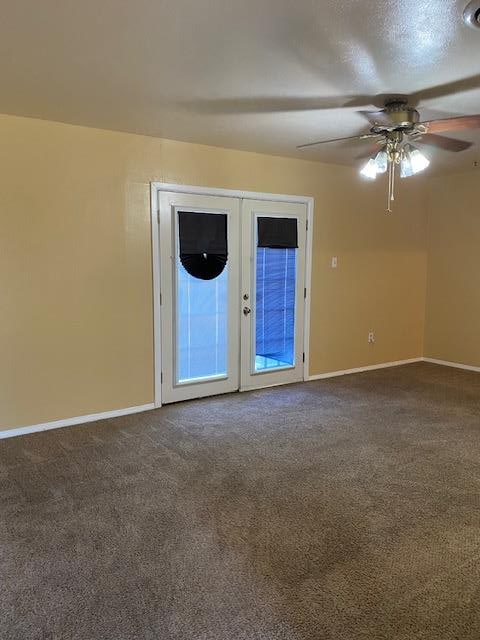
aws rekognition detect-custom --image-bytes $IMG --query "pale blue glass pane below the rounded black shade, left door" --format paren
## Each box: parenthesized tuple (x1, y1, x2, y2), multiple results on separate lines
(176, 254, 228, 383)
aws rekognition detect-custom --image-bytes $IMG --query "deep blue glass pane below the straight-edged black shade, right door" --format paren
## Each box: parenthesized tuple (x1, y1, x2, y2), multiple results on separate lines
(255, 247, 297, 372)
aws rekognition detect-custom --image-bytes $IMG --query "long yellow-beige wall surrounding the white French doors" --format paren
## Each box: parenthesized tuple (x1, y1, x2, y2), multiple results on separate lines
(0, 116, 426, 428)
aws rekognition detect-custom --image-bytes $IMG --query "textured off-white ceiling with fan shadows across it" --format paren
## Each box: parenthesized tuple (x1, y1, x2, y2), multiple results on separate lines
(0, 0, 480, 170)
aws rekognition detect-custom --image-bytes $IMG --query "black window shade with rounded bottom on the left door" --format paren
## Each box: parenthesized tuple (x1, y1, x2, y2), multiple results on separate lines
(178, 211, 228, 280)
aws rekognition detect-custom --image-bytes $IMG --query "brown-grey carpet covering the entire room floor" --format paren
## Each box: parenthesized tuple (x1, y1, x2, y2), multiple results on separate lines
(0, 364, 480, 640)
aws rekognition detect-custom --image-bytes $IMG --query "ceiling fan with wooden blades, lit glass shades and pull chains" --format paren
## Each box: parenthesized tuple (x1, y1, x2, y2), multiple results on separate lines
(297, 98, 480, 213)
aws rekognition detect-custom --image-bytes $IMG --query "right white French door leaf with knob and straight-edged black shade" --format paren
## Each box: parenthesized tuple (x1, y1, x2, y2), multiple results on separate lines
(240, 200, 307, 390)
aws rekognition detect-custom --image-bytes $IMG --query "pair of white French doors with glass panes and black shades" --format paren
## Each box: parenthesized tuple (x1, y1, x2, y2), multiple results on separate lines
(158, 192, 306, 403)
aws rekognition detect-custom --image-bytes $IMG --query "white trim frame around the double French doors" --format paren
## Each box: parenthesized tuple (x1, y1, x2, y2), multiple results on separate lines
(150, 182, 314, 407)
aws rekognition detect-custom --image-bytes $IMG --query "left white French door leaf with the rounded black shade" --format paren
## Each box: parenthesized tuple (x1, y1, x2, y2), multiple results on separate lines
(159, 192, 240, 403)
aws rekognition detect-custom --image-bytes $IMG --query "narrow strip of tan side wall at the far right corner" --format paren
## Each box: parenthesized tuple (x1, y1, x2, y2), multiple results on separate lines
(425, 169, 480, 367)
